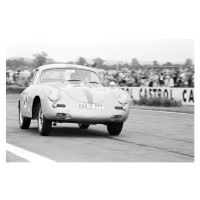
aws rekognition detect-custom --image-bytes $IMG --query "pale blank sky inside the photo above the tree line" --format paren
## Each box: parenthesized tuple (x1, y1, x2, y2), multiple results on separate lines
(6, 38, 194, 63)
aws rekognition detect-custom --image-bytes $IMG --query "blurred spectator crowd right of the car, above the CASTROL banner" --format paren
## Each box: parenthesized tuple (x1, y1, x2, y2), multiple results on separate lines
(101, 67, 194, 87)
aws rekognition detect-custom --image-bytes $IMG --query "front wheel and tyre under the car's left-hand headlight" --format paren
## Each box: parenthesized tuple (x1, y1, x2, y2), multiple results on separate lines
(38, 104, 52, 136)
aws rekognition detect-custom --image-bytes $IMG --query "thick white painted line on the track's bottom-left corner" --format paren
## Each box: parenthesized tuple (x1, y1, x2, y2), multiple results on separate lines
(6, 143, 54, 163)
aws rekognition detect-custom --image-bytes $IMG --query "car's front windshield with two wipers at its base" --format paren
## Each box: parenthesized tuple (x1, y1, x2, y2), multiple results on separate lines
(41, 69, 99, 84)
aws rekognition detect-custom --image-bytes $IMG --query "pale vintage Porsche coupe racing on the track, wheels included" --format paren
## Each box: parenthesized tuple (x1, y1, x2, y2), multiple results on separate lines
(18, 64, 130, 136)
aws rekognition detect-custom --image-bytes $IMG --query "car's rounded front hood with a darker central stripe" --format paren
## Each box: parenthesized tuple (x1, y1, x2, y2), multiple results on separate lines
(48, 83, 106, 104)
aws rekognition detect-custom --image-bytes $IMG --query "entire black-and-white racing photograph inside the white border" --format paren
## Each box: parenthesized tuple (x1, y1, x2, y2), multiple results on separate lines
(6, 39, 195, 162)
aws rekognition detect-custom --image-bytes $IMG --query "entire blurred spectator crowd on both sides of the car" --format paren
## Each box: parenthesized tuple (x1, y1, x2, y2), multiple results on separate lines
(6, 67, 194, 87)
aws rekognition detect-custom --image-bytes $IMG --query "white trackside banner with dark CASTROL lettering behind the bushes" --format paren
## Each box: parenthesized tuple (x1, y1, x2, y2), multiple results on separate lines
(121, 87, 194, 105)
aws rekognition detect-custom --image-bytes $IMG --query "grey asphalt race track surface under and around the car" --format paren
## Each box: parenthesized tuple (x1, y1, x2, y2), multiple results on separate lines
(6, 95, 194, 162)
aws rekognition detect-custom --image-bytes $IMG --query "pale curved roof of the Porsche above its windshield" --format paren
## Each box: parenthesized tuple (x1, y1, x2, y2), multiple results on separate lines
(37, 64, 96, 72)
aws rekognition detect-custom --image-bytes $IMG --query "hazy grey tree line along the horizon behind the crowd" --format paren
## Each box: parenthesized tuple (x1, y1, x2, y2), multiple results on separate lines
(6, 51, 193, 70)
